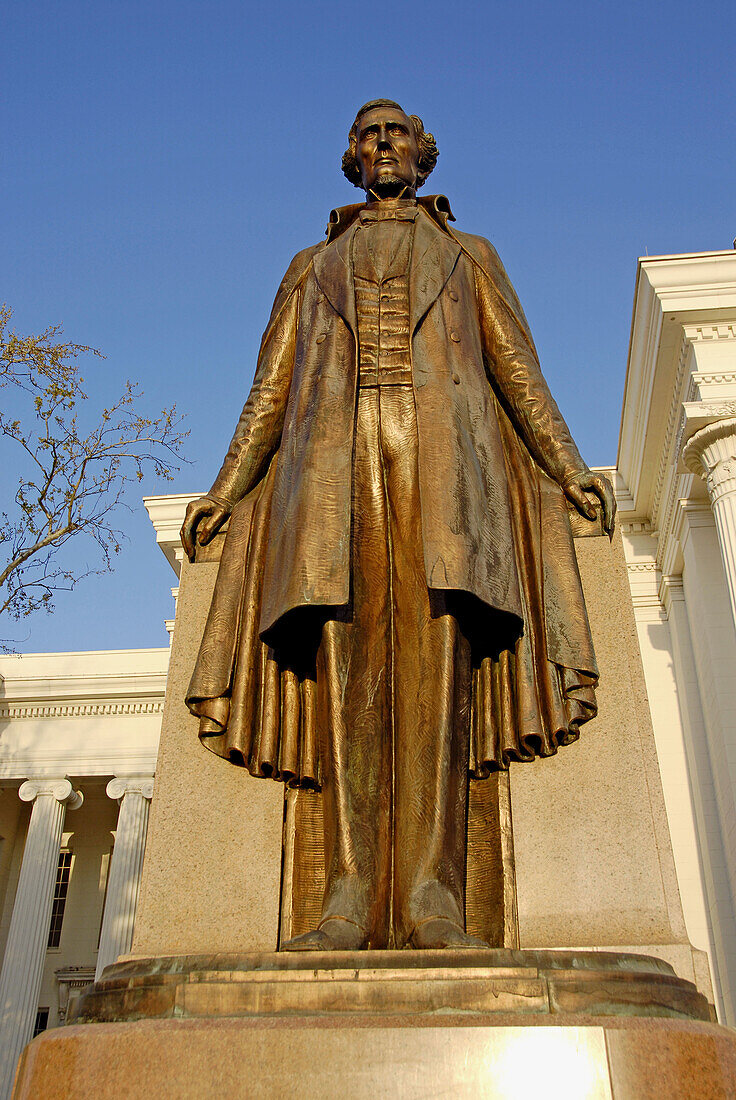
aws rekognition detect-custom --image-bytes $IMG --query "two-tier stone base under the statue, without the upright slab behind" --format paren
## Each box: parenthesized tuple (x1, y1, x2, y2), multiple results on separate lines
(14, 950, 736, 1100)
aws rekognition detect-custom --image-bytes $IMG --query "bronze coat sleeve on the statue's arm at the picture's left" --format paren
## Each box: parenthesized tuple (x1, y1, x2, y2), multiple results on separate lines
(207, 245, 319, 509)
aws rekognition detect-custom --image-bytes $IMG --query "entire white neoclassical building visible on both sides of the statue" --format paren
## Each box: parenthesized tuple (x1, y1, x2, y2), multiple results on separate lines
(0, 251, 736, 1098)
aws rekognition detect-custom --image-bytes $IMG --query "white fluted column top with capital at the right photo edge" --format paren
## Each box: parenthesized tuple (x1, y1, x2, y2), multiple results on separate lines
(682, 418, 736, 623)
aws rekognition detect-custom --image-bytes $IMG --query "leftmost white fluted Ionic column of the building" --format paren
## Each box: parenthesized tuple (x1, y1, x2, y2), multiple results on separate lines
(0, 778, 83, 1100)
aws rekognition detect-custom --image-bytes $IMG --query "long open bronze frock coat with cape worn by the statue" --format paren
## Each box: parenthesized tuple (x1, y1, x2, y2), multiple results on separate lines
(187, 196, 597, 788)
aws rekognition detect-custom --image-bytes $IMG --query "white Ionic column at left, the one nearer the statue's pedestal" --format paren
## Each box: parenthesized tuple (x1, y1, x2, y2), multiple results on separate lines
(95, 776, 153, 980)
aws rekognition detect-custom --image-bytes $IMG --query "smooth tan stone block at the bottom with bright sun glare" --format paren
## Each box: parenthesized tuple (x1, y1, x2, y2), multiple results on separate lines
(13, 1013, 736, 1100)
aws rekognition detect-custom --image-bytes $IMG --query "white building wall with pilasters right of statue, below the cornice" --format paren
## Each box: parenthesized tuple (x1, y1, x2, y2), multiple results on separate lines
(624, 499, 736, 1021)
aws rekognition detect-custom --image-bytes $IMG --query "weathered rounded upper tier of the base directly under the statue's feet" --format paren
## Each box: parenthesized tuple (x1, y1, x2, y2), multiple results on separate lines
(69, 948, 712, 1023)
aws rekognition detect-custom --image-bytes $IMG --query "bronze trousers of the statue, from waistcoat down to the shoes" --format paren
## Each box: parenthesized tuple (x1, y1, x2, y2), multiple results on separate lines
(317, 385, 472, 947)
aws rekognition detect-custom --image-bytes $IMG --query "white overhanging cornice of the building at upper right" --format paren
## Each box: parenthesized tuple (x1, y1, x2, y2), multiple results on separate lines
(617, 250, 736, 575)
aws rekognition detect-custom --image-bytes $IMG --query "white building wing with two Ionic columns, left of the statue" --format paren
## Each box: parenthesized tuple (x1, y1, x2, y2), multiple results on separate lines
(0, 649, 168, 1096)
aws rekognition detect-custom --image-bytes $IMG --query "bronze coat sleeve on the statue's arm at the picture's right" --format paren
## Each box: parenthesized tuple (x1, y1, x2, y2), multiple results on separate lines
(458, 234, 587, 485)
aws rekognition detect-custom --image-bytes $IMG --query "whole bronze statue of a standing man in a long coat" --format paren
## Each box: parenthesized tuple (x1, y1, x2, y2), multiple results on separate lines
(182, 100, 615, 950)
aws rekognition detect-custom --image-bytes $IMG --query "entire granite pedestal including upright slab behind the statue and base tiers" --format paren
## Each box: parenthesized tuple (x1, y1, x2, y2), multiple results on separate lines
(15, 519, 736, 1100)
